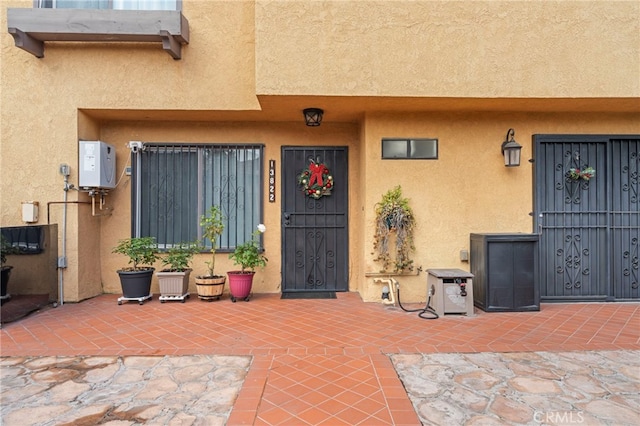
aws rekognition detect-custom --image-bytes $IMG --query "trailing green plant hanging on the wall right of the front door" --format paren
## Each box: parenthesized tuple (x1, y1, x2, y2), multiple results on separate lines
(373, 186, 416, 272)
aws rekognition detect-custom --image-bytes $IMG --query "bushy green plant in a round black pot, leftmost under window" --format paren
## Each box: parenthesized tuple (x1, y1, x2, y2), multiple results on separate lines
(112, 237, 158, 305)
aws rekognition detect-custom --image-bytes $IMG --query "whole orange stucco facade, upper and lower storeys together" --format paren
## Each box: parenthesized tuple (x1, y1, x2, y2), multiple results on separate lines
(0, 0, 640, 301)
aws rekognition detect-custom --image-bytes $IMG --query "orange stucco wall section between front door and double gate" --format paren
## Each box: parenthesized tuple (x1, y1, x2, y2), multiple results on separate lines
(361, 112, 639, 300)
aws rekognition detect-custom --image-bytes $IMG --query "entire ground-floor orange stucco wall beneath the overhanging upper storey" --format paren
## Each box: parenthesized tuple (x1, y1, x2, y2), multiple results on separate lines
(78, 113, 638, 300)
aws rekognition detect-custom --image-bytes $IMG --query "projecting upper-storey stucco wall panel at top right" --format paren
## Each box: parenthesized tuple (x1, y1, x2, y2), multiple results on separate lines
(256, 0, 640, 98)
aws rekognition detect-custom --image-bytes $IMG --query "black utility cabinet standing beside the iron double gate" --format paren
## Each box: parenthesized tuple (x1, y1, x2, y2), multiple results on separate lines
(470, 233, 540, 312)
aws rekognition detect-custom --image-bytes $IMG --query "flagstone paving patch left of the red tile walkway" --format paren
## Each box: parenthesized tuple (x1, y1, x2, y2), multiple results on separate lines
(0, 355, 251, 426)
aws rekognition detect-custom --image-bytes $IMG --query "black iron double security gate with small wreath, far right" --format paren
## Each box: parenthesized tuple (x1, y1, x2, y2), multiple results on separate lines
(534, 135, 640, 301)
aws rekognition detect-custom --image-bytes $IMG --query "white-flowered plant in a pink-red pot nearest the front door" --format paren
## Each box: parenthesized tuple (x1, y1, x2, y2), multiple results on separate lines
(227, 224, 269, 302)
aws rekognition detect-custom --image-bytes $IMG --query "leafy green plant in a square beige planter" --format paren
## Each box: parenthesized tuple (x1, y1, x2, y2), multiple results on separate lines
(156, 243, 200, 303)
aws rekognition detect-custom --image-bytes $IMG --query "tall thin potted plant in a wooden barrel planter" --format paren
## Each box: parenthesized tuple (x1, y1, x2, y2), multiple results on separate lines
(195, 206, 226, 302)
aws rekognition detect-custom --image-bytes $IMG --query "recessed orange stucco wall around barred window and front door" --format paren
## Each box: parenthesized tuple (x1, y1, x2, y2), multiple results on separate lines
(101, 122, 362, 293)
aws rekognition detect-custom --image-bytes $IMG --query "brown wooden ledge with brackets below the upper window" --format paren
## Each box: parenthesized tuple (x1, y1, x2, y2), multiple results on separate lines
(7, 8, 189, 59)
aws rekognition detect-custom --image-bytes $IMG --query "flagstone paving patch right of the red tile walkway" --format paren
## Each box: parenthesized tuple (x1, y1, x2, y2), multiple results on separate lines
(391, 351, 640, 426)
